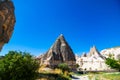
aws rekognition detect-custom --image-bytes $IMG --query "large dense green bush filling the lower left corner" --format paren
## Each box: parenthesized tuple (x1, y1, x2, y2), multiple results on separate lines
(0, 51, 39, 80)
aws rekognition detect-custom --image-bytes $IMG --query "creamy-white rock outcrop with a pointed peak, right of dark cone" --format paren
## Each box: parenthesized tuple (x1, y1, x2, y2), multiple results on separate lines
(76, 46, 110, 71)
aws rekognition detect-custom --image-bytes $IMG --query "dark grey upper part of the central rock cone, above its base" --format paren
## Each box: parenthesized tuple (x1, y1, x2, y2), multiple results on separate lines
(44, 35, 75, 62)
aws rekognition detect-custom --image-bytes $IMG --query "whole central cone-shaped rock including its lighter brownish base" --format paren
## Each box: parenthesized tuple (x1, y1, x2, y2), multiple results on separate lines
(42, 35, 76, 67)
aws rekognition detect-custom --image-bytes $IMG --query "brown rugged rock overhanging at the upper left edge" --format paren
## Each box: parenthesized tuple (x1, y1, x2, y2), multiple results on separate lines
(0, 0, 15, 50)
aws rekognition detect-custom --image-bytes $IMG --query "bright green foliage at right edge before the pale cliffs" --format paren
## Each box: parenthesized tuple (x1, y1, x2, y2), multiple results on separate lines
(106, 58, 120, 71)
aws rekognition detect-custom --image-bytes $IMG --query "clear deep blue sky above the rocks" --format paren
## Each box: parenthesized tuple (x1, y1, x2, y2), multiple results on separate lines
(0, 0, 120, 56)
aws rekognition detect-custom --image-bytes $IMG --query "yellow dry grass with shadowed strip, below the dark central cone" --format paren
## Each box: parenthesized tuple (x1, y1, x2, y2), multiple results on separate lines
(37, 65, 70, 80)
